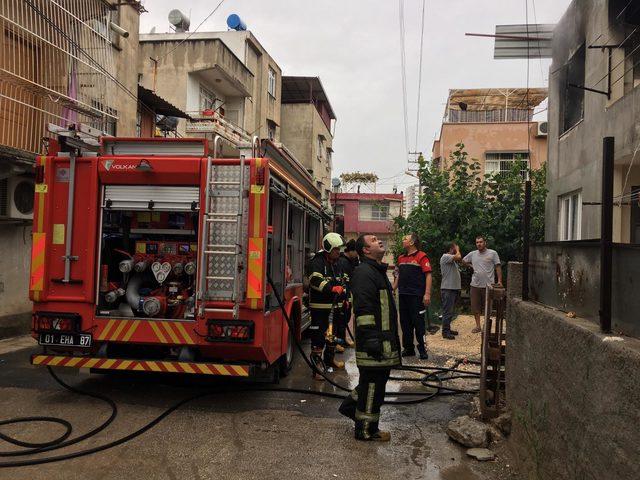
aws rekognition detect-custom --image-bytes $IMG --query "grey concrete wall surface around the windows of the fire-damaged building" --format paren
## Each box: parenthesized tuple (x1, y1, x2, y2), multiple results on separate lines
(545, 0, 640, 242)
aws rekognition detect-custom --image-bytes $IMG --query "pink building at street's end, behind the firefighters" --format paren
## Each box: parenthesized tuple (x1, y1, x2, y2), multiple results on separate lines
(331, 193, 404, 263)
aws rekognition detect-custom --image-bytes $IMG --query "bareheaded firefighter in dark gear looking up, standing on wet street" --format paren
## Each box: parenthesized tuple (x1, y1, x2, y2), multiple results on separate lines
(339, 235, 401, 442)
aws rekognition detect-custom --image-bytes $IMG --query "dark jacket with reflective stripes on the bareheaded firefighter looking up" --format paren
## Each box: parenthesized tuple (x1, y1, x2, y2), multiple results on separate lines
(351, 258, 401, 368)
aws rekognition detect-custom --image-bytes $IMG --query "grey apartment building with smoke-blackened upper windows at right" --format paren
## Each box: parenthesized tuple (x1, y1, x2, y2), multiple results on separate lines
(545, 0, 640, 244)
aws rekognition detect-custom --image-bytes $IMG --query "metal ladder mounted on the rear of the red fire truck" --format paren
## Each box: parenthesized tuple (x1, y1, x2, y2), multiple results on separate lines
(198, 142, 249, 319)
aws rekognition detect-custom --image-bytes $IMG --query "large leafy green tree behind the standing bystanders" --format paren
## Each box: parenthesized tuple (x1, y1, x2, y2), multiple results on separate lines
(395, 143, 546, 284)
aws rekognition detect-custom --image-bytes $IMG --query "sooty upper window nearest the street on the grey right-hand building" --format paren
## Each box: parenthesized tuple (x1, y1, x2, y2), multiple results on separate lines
(558, 44, 586, 134)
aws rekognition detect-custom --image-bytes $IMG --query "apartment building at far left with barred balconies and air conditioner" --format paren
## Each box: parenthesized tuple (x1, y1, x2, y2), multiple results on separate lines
(0, 0, 144, 336)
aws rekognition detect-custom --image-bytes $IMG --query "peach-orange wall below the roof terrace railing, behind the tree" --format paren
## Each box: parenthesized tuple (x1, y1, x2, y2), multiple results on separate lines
(432, 122, 547, 174)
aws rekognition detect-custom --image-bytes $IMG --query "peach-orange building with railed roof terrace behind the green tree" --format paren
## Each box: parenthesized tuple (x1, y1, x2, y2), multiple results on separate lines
(431, 88, 548, 175)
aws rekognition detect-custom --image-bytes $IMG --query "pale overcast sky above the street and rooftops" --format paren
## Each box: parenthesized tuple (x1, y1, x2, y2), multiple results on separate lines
(140, 0, 570, 191)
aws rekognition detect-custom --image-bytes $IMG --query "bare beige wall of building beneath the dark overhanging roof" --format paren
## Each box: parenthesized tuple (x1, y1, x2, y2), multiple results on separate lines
(280, 103, 333, 199)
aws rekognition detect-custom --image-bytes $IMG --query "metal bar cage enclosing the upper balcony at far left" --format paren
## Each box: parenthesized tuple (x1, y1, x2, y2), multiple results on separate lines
(0, 0, 117, 153)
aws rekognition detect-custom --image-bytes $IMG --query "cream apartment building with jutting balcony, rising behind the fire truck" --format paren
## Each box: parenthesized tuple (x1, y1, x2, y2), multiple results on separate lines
(137, 30, 282, 155)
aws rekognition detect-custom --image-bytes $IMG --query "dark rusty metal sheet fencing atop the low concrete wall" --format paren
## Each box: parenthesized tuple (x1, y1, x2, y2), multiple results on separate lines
(529, 240, 640, 337)
